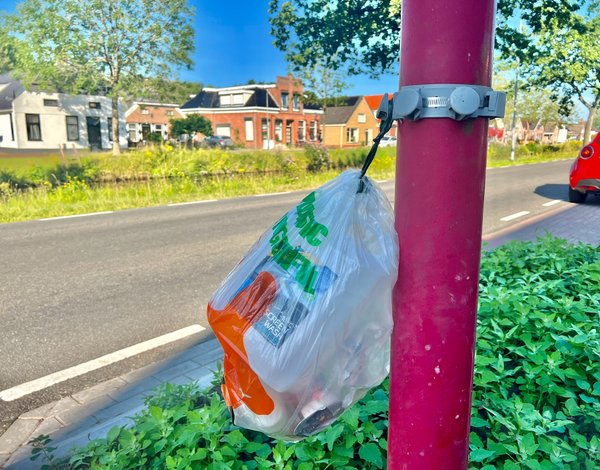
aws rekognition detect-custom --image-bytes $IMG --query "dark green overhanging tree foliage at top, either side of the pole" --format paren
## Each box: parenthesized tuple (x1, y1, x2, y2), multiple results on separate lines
(269, 0, 586, 77)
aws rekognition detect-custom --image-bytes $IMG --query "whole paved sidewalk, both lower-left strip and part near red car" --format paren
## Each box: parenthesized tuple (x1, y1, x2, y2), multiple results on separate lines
(0, 198, 600, 470)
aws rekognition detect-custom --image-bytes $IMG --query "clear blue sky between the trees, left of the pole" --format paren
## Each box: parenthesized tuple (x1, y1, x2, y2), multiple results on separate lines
(0, 0, 398, 95)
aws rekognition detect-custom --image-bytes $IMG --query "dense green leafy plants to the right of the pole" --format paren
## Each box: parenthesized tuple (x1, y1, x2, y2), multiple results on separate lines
(471, 237, 600, 469)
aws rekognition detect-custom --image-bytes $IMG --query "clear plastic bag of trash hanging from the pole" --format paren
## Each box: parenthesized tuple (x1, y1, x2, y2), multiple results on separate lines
(208, 170, 398, 440)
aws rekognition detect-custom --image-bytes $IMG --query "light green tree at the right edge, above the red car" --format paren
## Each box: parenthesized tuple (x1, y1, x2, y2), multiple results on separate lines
(528, 2, 600, 142)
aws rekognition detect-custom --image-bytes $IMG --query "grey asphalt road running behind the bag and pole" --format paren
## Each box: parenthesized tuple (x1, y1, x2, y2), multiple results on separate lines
(0, 161, 571, 421)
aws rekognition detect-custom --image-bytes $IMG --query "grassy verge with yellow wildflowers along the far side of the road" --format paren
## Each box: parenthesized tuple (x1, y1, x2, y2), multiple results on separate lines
(0, 143, 578, 222)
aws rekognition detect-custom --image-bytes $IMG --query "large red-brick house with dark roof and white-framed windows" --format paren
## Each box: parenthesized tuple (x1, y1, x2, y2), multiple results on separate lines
(181, 76, 323, 148)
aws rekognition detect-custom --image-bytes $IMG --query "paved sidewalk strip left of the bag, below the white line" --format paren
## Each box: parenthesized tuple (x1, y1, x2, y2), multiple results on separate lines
(0, 339, 223, 470)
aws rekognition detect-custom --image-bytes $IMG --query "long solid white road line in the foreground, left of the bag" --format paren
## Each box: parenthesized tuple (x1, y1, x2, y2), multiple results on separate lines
(0, 325, 205, 401)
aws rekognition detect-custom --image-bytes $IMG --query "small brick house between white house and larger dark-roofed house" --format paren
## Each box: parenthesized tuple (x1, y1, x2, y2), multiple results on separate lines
(125, 101, 184, 145)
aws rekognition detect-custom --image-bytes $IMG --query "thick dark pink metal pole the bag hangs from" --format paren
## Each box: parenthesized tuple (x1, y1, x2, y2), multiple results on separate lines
(388, 0, 495, 470)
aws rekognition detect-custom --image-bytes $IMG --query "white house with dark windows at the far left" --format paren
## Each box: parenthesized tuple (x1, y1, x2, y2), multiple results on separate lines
(0, 75, 127, 150)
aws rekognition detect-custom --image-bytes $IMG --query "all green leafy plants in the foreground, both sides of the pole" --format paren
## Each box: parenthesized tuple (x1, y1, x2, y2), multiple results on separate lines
(34, 237, 600, 470)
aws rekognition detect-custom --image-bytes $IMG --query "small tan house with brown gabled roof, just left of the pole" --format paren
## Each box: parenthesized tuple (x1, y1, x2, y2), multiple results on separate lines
(323, 96, 379, 147)
